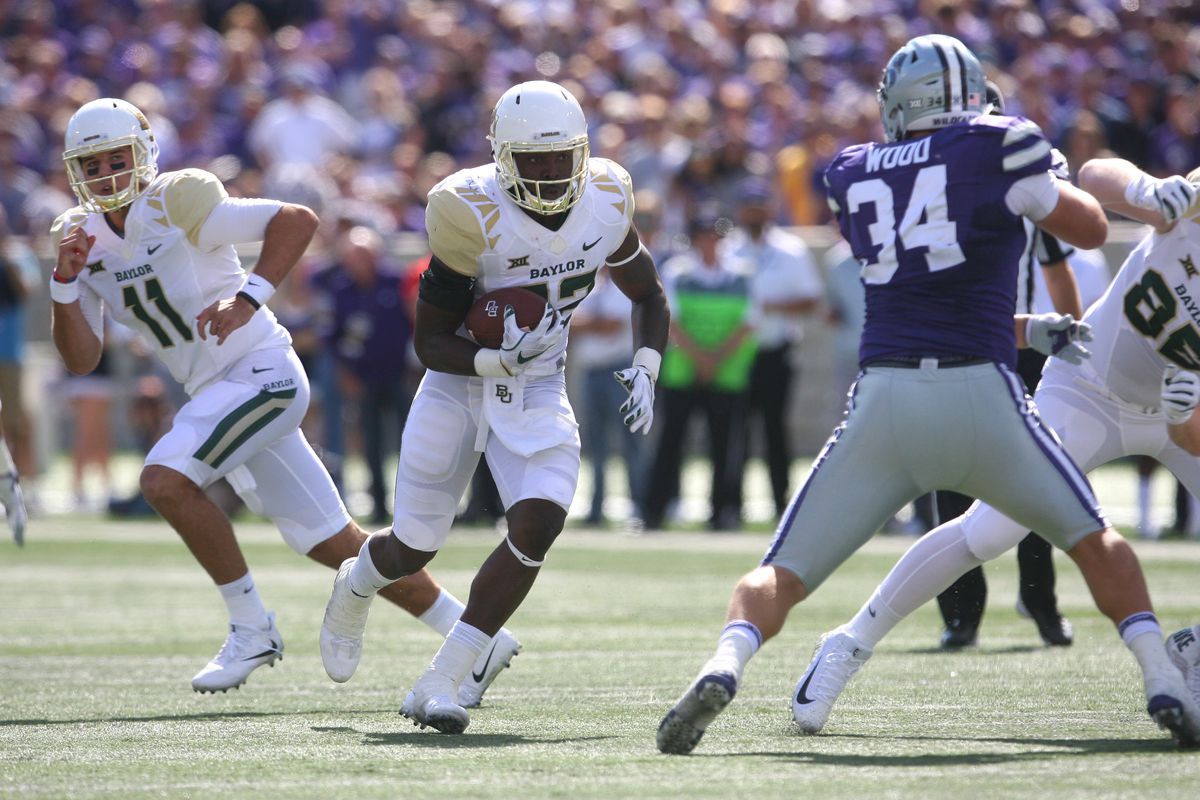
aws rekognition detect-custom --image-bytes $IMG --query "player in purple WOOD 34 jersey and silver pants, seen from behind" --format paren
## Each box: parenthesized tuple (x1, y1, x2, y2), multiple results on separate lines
(658, 35, 1200, 753)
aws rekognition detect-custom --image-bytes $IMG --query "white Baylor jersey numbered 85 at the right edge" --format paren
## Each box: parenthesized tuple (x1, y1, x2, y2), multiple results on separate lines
(1046, 217, 1200, 409)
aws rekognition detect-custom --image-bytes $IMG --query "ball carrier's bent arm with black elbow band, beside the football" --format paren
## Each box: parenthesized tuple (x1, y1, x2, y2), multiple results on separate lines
(413, 255, 480, 375)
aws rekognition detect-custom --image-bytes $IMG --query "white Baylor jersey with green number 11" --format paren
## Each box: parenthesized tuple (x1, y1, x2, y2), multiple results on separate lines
(50, 169, 292, 396)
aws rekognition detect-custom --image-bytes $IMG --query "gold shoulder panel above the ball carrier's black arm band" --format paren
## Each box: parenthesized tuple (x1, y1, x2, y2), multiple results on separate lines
(425, 184, 487, 277)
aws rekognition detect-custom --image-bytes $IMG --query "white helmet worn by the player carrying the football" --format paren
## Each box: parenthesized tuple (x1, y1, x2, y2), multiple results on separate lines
(487, 80, 590, 213)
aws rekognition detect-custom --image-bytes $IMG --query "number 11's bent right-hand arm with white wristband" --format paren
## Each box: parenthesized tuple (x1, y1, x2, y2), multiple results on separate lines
(196, 204, 318, 345)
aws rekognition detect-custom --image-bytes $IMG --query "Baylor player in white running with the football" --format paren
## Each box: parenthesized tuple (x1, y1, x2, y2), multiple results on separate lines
(322, 80, 670, 733)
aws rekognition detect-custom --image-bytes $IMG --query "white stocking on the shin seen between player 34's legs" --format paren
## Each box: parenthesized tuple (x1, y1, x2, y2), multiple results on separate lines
(873, 517, 983, 618)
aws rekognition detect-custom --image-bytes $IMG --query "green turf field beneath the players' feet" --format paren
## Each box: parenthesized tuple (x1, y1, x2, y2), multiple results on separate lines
(0, 517, 1200, 800)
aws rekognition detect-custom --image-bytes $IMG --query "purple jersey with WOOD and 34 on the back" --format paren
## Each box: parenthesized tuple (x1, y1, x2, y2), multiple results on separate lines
(826, 116, 1050, 368)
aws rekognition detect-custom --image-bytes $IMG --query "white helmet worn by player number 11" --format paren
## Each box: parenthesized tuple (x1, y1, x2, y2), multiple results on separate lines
(62, 97, 158, 212)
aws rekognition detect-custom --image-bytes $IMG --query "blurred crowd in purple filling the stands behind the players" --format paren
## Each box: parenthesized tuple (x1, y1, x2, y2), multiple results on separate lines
(0, 0, 1200, 524)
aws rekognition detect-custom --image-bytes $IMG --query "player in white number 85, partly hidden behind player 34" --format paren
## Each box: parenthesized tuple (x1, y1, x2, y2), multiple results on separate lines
(797, 158, 1200, 744)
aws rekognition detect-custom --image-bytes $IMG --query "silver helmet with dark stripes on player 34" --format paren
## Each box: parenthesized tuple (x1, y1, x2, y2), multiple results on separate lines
(878, 34, 988, 142)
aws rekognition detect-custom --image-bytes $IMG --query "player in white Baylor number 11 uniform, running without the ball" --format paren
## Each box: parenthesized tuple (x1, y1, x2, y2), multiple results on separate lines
(50, 98, 520, 704)
